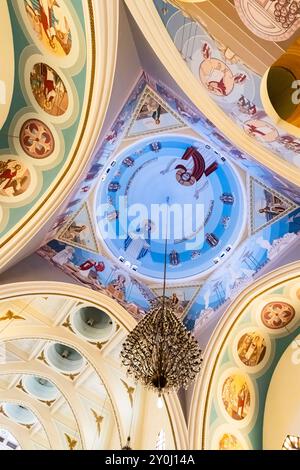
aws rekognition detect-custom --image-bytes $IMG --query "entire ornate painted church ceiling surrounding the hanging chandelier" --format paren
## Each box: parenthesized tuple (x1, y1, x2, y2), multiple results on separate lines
(0, 0, 300, 450)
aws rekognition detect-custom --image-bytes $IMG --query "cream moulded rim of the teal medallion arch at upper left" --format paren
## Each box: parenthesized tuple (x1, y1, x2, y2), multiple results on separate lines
(0, 0, 119, 272)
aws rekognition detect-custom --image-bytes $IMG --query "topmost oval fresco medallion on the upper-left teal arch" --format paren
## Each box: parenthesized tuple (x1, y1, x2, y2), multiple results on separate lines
(21, 0, 72, 57)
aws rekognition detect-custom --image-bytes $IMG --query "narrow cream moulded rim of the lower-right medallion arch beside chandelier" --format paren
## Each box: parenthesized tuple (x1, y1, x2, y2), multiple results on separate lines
(188, 261, 300, 449)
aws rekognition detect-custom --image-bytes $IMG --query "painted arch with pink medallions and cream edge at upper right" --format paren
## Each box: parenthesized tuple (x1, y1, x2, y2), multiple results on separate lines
(126, 0, 299, 184)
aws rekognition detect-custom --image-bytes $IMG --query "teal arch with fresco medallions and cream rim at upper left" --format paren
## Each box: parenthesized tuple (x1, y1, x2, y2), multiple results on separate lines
(0, 0, 119, 270)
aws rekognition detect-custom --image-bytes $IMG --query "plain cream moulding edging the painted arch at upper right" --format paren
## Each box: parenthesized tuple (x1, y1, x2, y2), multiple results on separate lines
(125, 0, 300, 185)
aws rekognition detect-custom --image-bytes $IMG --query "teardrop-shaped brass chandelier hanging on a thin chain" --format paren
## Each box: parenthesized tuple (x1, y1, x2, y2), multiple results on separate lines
(121, 206, 202, 397)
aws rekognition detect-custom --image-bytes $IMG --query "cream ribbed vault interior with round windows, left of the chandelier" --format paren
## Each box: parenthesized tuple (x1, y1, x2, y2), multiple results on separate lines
(0, 285, 173, 450)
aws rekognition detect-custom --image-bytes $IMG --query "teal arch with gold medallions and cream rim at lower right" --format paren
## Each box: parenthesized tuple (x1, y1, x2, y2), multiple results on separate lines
(189, 261, 300, 450)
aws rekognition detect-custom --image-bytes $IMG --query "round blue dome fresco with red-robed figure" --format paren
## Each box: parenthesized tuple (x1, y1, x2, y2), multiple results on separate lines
(96, 135, 244, 279)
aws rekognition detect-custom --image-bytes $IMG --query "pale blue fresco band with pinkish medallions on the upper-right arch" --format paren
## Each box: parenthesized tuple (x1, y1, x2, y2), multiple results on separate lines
(154, 0, 300, 167)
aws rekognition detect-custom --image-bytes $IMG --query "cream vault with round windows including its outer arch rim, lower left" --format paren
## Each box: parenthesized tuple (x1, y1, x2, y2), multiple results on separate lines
(0, 282, 188, 449)
